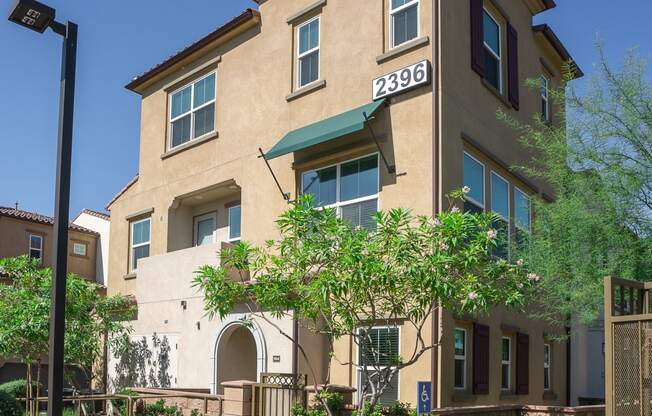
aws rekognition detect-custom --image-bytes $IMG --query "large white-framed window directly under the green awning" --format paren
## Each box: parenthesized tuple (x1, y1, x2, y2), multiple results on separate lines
(301, 153, 380, 229)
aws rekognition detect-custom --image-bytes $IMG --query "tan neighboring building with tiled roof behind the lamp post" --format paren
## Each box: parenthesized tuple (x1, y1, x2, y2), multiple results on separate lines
(0, 206, 109, 386)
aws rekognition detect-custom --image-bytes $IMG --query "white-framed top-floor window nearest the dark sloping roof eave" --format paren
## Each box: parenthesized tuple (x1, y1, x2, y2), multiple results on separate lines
(168, 72, 216, 149)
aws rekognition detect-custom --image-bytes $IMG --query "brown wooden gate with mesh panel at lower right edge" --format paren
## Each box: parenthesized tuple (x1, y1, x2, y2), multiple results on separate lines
(604, 277, 652, 416)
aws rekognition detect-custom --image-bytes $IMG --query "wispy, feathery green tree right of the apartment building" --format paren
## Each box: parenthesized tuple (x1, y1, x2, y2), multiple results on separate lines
(498, 48, 652, 325)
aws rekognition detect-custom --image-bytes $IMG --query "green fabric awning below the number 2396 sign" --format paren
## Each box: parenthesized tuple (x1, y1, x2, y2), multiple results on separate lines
(265, 99, 385, 160)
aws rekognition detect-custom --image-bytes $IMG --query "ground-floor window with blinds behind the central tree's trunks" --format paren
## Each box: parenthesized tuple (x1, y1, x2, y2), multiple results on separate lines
(358, 326, 401, 405)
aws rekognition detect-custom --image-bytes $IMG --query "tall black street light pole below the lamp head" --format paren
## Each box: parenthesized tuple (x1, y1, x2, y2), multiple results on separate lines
(48, 22, 77, 416)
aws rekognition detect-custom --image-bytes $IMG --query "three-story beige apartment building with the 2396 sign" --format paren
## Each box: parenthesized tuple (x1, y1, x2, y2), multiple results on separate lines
(107, 0, 581, 407)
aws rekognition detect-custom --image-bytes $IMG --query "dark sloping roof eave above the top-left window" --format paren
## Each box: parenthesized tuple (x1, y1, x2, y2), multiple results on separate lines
(125, 9, 260, 93)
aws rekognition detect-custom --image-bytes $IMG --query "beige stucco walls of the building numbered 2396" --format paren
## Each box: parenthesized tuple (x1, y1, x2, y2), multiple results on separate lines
(109, 0, 576, 405)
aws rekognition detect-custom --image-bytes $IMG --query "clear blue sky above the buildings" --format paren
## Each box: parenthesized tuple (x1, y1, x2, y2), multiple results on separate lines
(0, 0, 652, 216)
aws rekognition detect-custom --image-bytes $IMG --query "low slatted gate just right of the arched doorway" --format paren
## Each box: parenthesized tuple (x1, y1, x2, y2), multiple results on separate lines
(251, 373, 307, 416)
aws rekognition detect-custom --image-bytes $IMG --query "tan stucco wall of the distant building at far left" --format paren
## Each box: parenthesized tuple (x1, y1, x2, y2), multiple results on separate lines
(0, 216, 97, 280)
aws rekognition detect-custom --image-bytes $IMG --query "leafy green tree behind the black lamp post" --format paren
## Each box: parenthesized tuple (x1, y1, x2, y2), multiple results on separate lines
(0, 256, 133, 412)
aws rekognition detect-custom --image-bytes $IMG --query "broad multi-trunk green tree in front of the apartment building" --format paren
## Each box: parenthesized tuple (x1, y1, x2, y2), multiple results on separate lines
(194, 190, 538, 414)
